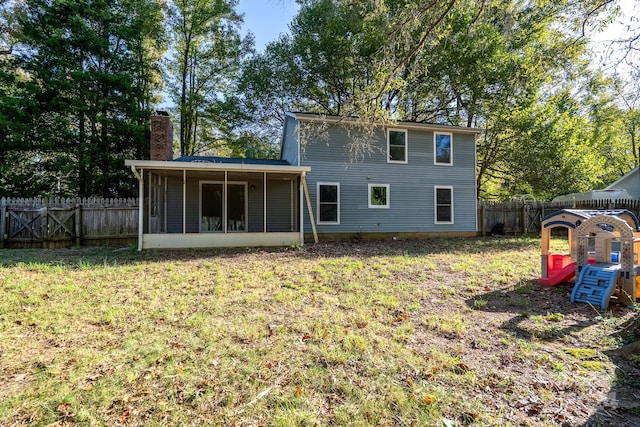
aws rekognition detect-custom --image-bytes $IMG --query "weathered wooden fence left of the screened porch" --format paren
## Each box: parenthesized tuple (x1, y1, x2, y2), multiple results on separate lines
(0, 198, 138, 248)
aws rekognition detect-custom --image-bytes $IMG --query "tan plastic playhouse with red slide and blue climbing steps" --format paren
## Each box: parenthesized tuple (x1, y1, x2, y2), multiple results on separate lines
(538, 209, 640, 309)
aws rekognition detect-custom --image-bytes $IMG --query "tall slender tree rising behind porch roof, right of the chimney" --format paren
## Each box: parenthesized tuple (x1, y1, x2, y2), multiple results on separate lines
(168, 0, 252, 155)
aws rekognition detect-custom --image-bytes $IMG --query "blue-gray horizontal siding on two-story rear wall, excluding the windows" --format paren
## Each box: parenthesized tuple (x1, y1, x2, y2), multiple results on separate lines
(301, 126, 476, 233)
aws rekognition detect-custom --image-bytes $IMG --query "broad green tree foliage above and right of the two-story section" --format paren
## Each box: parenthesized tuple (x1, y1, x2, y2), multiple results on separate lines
(240, 0, 634, 198)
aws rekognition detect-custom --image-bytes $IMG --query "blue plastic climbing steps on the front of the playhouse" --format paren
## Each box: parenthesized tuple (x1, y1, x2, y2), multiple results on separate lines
(571, 263, 620, 310)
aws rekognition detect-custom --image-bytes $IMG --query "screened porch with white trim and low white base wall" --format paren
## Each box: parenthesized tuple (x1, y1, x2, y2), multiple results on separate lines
(127, 161, 310, 249)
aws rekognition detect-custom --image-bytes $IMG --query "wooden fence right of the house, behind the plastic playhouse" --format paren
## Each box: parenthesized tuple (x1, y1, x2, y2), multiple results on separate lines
(478, 199, 640, 236)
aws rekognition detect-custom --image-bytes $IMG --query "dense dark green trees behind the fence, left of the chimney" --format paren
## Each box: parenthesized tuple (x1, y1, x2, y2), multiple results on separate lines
(0, 0, 163, 196)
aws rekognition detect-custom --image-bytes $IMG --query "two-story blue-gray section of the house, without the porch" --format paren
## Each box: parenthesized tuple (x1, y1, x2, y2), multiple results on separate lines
(281, 113, 480, 238)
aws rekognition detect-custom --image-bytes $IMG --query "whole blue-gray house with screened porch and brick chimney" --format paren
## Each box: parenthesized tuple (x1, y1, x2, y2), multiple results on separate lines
(125, 113, 480, 250)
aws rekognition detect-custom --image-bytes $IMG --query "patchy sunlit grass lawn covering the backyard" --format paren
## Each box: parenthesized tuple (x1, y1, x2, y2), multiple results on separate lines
(0, 238, 640, 426)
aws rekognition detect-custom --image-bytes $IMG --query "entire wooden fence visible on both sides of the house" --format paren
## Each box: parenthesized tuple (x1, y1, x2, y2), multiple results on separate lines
(0, 198, 640, 248)
